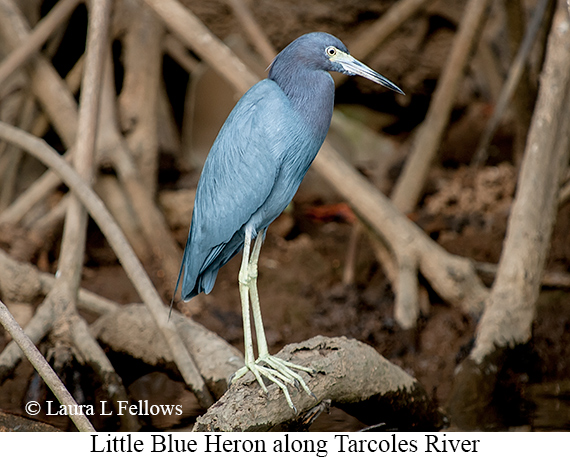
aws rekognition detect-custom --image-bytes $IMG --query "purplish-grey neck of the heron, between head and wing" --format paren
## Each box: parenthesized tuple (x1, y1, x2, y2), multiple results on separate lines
(270, 69, 334, 140)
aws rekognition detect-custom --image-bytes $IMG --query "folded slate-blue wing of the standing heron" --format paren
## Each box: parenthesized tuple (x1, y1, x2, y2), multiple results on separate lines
(181, 80, 288, 300)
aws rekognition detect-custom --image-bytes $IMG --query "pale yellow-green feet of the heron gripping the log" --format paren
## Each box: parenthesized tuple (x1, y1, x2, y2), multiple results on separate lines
(230, 354, 316, 413)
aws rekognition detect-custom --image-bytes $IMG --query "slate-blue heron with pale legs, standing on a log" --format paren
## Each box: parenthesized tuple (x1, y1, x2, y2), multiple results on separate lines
(176, 32, 403, 409)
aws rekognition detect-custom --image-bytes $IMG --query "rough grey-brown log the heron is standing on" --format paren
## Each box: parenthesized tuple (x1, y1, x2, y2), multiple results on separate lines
(194, 336, 442, 432)
